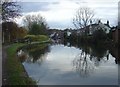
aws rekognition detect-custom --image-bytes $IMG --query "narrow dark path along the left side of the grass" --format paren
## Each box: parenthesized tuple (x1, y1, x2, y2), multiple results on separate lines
(2, 46, 9, 85)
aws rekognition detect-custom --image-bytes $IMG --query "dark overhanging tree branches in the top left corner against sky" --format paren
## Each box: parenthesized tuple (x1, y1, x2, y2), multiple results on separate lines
(2, 0, 21, 21)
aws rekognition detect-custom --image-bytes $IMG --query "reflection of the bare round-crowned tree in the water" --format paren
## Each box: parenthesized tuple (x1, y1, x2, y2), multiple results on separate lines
(73, 51, 94, 77)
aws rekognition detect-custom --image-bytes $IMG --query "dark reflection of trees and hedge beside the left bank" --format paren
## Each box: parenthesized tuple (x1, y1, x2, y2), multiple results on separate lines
(18, 45, 50, 64)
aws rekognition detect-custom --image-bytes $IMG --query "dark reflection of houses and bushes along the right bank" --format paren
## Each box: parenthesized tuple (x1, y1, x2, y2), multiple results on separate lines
(63, 42, 120, 65)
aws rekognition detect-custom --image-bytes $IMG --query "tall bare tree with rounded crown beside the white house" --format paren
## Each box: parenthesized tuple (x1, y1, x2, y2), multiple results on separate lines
(73, 7, 94, 33)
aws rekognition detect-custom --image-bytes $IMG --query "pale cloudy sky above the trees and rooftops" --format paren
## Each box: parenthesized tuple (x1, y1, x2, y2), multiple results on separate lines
(16, 0, 119, 29)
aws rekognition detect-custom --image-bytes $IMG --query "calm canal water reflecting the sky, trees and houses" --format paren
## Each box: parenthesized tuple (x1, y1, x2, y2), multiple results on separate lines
(17, 43, 118, 85)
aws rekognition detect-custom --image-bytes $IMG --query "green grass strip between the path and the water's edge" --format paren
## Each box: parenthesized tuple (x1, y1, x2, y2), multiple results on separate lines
(6, 43, 36, 85)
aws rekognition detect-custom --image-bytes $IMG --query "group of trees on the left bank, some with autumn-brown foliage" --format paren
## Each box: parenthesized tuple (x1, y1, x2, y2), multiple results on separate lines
(1, 0, 49, 43)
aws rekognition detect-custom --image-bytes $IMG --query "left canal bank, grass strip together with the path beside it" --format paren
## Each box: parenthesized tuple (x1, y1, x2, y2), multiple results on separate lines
(2, 43, 36, 86)
